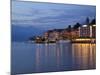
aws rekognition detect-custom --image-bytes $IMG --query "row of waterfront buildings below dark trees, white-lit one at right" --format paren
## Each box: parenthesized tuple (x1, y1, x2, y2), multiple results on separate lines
(44, 24, 96, 41)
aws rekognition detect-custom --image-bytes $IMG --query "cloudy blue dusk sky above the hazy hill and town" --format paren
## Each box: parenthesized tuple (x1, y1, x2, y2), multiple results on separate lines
(12, 1, 96, 28)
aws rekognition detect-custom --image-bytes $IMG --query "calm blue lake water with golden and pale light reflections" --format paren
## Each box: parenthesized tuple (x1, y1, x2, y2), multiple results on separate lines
(11, 42, 96, 75)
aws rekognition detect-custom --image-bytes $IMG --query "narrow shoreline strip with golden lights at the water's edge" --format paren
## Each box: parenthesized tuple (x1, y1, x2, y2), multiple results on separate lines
(30, 38, 96, 44)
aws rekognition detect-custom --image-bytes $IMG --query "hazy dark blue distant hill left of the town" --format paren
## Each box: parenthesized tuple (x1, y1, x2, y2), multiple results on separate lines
(11, 25, 45, 41)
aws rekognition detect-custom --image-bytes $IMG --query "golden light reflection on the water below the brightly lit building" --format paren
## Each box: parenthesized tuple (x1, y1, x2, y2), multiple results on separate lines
(72, 44, 96, 69)
